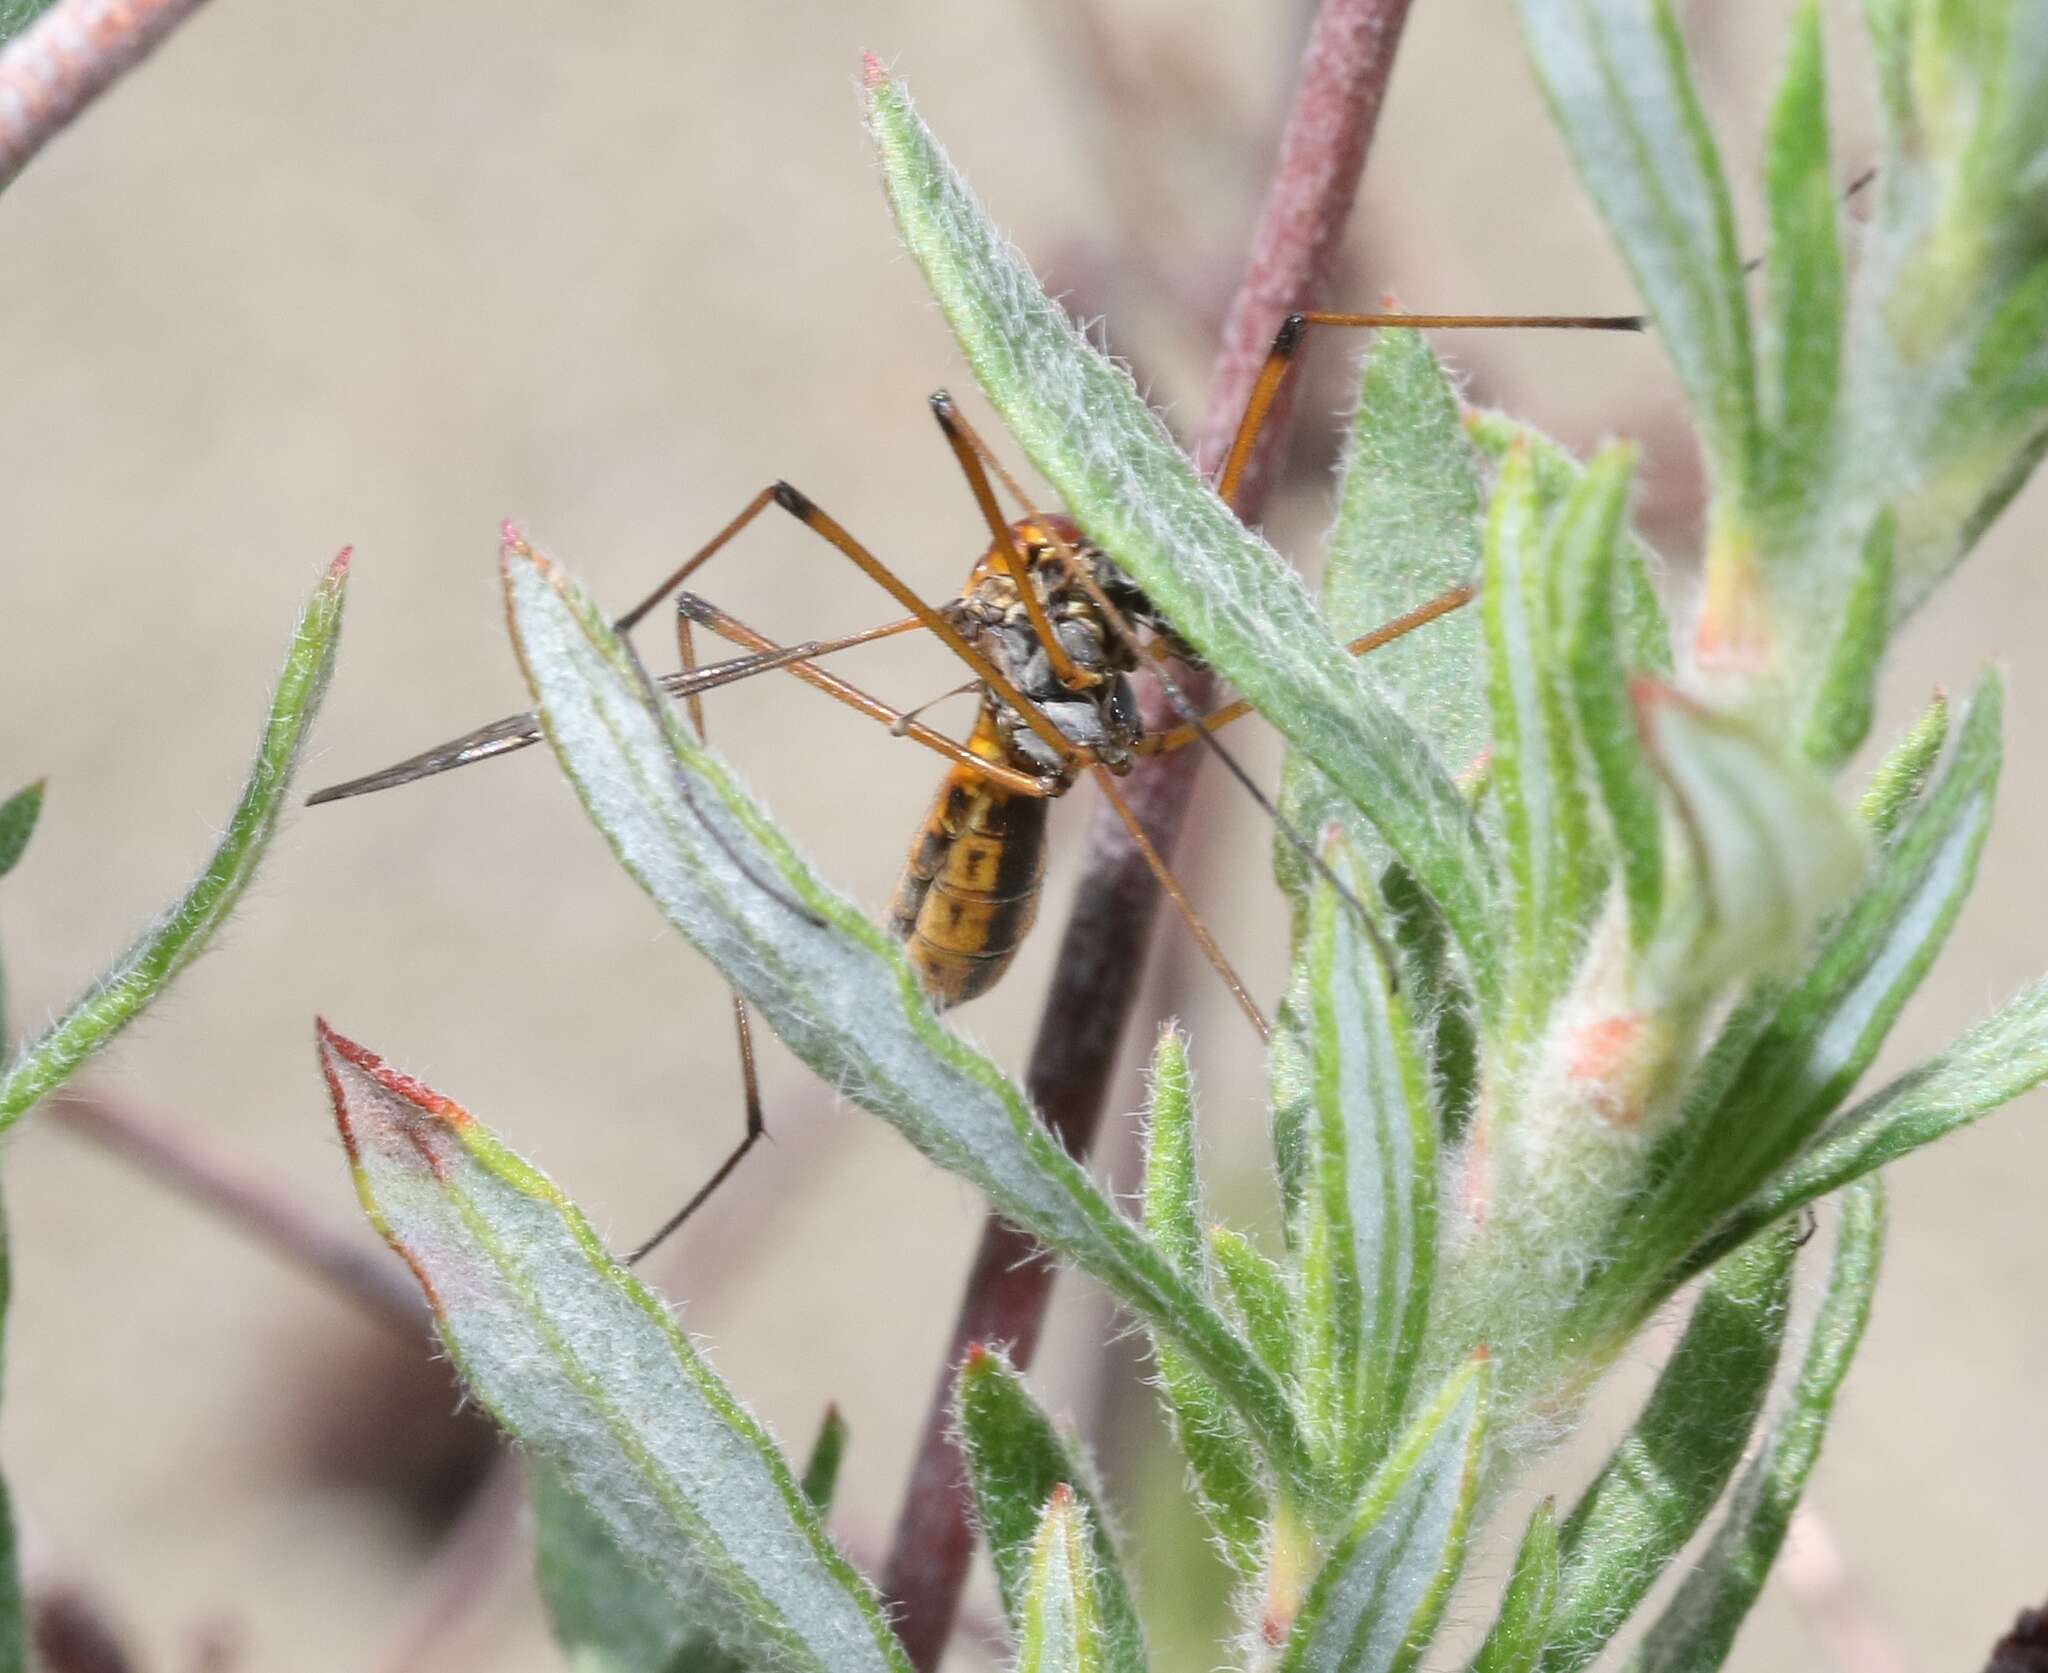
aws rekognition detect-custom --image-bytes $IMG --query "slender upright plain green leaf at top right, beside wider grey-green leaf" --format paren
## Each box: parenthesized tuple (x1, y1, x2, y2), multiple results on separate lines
(1763, 0, 1851, 528)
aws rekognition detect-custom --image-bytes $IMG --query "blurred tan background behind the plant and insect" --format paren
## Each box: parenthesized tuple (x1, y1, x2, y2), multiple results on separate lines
(0, 0, 2048, 1673)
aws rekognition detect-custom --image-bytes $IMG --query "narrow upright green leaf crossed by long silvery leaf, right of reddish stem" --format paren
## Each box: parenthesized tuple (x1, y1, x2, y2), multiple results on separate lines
(1138, 1028, 1280, 1575)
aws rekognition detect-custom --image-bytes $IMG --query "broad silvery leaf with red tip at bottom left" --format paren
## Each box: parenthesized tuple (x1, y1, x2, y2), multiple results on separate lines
(319, 1024, 909, 1673)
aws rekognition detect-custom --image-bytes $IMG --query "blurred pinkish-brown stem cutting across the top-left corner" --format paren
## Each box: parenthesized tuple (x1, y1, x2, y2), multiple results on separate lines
(0, 0, 216, 186)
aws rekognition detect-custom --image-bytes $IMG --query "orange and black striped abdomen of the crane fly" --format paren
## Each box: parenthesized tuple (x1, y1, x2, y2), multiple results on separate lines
(889, 711, 1044, 1010)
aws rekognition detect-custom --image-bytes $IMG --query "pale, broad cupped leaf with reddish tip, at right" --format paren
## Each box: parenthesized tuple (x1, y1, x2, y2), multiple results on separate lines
(1634, 680, 1868, 997)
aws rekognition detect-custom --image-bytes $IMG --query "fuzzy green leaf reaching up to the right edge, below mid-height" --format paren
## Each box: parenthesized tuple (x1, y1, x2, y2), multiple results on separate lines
(1714, 981, 2048, 1245)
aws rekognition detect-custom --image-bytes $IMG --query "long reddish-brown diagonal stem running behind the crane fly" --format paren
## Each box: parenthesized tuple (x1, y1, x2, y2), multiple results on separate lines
(883, 0, 1409, 1669)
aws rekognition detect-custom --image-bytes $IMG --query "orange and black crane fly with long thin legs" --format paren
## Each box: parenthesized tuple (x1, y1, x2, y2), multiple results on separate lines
(307, 303, 1645, 1261)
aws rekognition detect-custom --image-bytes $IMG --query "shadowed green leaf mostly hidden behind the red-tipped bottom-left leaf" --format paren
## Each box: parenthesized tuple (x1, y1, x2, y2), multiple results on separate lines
(532, 1407, 846, 1673)
